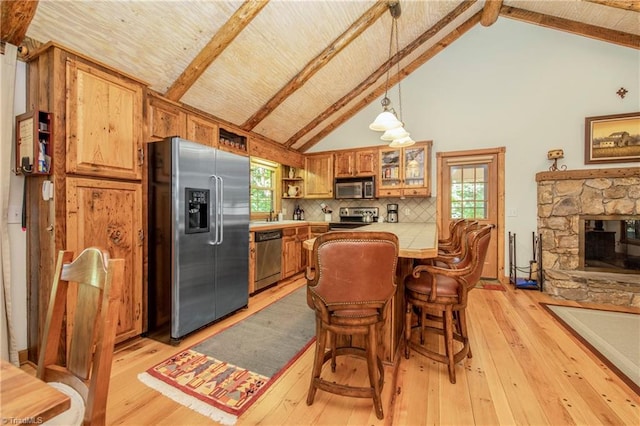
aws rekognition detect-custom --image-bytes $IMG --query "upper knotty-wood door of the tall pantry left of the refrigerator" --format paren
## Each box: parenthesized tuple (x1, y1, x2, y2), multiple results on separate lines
(66, 60, 143, 180)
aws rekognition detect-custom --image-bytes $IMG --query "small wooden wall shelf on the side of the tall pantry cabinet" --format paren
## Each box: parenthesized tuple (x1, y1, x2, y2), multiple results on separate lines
(15, 110, 53, 175)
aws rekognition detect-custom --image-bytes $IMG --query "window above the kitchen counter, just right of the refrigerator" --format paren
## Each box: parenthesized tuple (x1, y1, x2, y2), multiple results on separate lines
(251, 158, 278, 219)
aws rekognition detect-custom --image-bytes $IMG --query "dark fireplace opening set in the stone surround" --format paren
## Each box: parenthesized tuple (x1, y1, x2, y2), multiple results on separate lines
(579, 215, 640, 274)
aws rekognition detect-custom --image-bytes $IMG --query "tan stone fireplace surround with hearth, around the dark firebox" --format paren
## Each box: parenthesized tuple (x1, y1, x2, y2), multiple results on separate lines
(536, 167, 640, 307)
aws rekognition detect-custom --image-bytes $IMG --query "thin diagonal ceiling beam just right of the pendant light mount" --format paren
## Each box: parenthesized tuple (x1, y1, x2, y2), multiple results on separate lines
(284, 0, 476, 149)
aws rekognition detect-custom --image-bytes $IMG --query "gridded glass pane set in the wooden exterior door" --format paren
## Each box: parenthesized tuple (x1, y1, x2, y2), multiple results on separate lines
(451, 164, 489, 219)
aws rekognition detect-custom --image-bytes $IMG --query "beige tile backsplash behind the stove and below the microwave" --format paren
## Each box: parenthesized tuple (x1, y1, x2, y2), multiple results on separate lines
(282, 197, 436, 223)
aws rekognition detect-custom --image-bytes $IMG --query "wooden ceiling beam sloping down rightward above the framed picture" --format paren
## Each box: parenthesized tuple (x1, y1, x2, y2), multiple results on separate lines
(500, 6, 640, 49)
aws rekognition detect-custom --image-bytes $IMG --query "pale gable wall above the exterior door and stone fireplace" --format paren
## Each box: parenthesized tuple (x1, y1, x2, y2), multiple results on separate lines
(312, 17, 640, 267)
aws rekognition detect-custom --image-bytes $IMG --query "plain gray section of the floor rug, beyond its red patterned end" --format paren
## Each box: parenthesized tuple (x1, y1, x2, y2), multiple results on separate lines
(192, 286, 316, 377)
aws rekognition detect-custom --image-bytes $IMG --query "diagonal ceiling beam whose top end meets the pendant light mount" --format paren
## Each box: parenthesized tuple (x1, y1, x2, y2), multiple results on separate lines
(241, 2, 389, 131)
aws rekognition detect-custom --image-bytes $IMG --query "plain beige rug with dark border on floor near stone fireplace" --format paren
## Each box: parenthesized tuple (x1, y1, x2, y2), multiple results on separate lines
(543, 304, 640, 394)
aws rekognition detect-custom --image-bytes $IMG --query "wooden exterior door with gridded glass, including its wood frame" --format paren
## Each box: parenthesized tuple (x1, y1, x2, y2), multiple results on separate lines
(437, 148, 505, 279)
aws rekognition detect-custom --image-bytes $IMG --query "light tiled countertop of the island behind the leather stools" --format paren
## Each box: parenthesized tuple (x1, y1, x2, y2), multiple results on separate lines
(303, 222, 438, 259)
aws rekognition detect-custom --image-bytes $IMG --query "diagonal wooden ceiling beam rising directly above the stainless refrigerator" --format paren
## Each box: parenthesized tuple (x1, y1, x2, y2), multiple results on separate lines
(164, 0, 269, 101)
